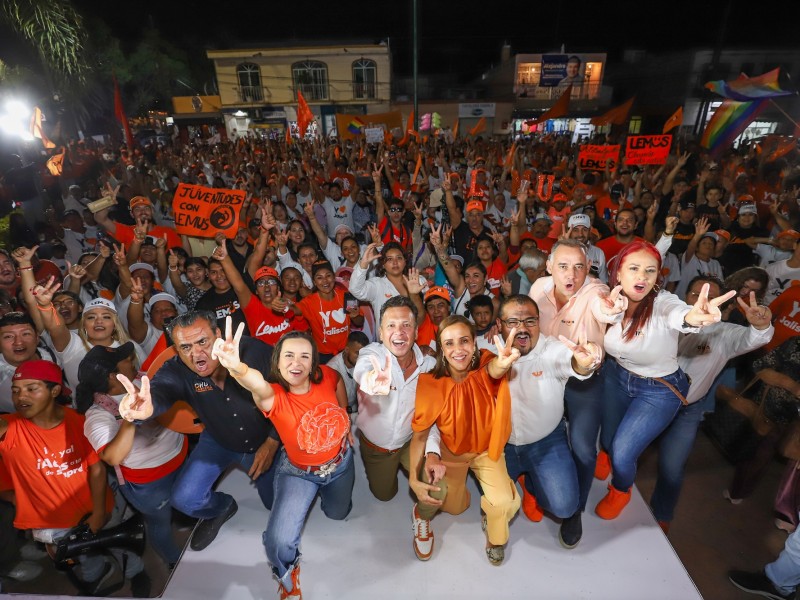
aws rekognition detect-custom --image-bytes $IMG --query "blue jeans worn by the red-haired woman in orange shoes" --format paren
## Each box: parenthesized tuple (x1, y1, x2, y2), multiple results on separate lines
(602, 364, 689, 491)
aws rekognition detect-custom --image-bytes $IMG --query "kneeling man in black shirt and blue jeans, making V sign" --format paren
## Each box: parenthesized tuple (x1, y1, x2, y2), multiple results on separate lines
(117, 311, 280, 550)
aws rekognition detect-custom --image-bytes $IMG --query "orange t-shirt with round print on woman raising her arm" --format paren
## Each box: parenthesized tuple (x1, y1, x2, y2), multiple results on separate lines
(264, 365, 350, 466)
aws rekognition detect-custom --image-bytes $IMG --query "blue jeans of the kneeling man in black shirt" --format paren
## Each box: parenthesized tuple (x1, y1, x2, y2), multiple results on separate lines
(170, 431, 275, 519)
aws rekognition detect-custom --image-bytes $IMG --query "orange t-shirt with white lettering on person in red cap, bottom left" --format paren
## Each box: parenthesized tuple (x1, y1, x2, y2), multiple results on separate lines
(0, 407, 114, 529)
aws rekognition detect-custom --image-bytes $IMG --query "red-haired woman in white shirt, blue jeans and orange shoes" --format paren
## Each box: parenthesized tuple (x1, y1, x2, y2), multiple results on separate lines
(595, 240, 736, 519)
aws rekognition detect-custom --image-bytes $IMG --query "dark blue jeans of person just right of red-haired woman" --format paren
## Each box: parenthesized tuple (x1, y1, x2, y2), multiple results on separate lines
(650, 402, 704, 522)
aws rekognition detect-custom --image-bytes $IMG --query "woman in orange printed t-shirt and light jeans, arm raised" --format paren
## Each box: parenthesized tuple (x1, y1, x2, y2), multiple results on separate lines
(214, 317, 355, 598)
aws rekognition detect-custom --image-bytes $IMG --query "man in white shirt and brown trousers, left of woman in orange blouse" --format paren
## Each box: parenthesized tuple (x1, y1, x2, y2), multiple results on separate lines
(353, 296, 447, 560)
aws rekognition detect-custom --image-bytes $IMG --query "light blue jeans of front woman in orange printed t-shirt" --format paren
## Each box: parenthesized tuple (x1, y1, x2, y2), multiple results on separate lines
(262, 447, 356, 591)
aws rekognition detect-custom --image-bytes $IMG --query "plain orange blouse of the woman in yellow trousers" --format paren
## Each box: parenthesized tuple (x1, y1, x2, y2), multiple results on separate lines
(411, 350, 511, 460)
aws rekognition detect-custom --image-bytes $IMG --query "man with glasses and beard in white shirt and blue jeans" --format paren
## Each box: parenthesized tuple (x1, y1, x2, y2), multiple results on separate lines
(497, 295, 603, 549)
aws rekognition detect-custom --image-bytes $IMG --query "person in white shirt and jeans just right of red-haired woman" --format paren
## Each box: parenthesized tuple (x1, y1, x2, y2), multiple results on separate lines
(650, 275, 775, 533)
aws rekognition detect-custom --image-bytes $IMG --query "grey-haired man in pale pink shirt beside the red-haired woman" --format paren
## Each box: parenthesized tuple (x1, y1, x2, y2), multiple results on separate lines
(522, 240, 616, 546)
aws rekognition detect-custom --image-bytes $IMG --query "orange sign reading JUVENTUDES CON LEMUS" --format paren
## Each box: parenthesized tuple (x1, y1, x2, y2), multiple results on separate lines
(172, 183, 242, 239)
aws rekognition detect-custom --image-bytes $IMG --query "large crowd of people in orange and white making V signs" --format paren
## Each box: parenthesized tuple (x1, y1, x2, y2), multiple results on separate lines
(0, 129, 800, 598)
